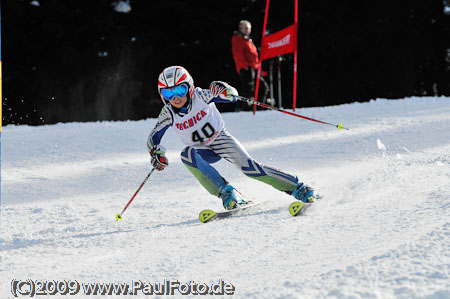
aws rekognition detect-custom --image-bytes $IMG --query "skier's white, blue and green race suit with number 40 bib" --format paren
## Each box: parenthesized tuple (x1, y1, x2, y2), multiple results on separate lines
(147, 87, 299, 196)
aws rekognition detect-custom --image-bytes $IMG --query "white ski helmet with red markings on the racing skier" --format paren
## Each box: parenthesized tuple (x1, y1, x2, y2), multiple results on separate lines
(158, 65, 194, 104)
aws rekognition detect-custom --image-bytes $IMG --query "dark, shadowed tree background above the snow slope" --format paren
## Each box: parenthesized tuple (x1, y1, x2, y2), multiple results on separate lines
(2, 0, 450, 125)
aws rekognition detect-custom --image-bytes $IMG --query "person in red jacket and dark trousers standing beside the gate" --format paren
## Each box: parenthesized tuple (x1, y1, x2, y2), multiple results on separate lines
(231, 20, 269, 111)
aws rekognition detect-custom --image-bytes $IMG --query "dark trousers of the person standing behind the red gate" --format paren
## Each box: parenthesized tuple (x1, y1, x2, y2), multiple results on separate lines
(236, 67, 269, 110)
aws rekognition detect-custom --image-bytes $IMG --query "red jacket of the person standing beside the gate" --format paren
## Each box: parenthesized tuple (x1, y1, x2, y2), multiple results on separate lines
(231, 31, 259, 74)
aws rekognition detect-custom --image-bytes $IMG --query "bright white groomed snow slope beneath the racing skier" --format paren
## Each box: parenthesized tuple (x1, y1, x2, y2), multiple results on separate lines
(0, 97, 450, 298)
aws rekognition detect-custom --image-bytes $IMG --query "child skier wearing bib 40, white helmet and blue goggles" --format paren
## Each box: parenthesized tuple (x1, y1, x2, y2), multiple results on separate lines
(147, 66, 315, 210)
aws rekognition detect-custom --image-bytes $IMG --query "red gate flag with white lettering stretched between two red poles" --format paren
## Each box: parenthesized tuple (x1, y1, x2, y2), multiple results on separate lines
(260, 24, 297, 61)
